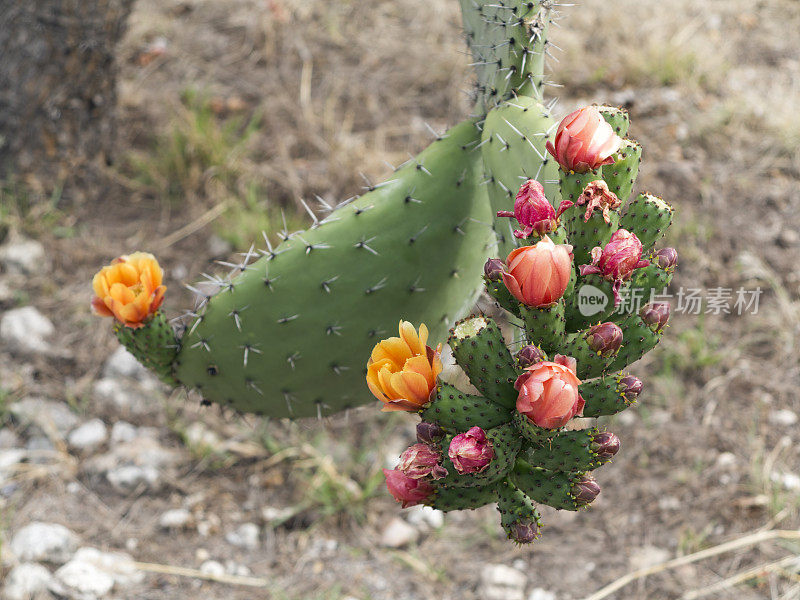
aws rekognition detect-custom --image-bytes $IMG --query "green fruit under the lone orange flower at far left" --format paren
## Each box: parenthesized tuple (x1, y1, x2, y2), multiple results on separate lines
(114, 312, 180, 385)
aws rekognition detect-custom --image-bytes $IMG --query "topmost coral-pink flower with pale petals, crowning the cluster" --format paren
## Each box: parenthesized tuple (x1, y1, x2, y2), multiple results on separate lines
(547, 106, 622, 173)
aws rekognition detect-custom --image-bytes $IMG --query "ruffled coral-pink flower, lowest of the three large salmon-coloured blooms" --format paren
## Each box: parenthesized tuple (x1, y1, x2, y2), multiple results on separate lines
(514, 356, 584, 429)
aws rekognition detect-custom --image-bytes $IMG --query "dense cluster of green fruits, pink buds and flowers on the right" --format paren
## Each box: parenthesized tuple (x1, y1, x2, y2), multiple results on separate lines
(376, 106, 677, 543)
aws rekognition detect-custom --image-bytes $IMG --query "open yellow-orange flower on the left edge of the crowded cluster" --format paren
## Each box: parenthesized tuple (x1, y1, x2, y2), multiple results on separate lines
(367, 321, 442, 412)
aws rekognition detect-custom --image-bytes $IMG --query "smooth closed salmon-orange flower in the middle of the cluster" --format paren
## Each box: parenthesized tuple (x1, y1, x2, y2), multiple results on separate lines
(503, 236, 572, 307)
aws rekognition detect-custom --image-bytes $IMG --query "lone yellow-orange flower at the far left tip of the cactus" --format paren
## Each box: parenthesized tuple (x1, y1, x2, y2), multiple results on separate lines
(92, 252, 167, 329)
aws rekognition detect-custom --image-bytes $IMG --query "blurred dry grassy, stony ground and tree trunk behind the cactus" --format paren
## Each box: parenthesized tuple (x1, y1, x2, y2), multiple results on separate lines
(0, 0, 800, 600)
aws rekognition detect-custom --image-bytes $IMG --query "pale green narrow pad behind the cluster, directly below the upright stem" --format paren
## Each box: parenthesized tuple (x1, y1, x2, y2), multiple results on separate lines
(481, 96, 561, 256)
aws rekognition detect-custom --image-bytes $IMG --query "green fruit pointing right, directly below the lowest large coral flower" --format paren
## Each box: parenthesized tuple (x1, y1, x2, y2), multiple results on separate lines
(520, 426, 603, 472)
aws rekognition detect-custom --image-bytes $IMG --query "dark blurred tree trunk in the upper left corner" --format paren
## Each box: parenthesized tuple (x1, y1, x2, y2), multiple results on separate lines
(0, 0, 134, 180)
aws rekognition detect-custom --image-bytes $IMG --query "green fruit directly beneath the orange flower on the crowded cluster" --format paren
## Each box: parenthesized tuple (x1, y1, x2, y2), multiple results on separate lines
(419, 384, 511, 432)
